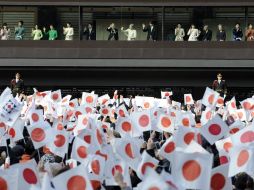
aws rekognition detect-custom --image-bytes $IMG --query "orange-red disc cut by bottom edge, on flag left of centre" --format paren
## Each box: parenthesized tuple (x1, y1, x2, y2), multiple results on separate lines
(67, 175, 86, 190)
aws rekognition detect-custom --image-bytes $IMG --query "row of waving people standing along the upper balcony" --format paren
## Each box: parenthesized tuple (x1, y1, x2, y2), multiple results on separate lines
(0, 21, 254, 41)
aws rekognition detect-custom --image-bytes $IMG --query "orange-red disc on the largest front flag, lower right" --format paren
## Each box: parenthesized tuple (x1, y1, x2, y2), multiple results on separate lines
(182, 160, 201, 181)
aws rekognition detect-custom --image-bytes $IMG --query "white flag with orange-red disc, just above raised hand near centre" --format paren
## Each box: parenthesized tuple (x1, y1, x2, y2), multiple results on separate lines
(131, 110, 151, 132)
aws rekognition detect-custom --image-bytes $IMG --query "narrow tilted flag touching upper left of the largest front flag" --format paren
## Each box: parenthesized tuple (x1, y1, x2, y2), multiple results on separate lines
(159, 136, 176, 161)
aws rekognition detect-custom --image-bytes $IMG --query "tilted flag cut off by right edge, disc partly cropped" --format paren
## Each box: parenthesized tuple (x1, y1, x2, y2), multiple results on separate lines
(231, 124, 254, 146)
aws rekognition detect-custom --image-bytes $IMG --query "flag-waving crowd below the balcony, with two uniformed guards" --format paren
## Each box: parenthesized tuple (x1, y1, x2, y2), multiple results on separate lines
(0, 73, 254, 190)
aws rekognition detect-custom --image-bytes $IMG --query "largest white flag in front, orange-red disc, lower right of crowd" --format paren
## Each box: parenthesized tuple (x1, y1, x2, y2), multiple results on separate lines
(172, 150, 213, 189)
